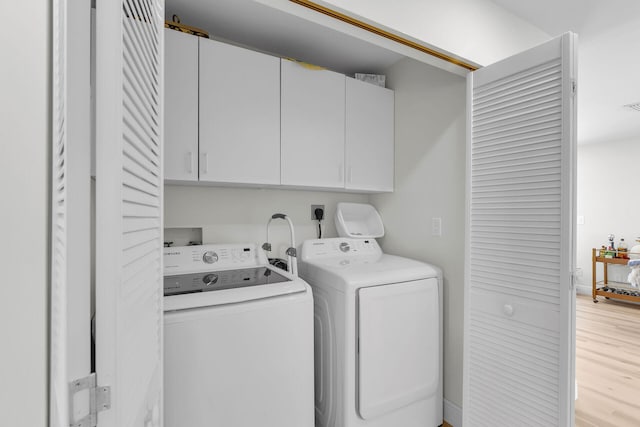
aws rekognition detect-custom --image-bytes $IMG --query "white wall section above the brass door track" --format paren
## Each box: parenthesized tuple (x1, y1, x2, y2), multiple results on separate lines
(319, 0, 550, 65)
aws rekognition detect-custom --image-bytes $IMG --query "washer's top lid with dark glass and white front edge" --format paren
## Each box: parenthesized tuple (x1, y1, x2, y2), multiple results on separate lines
(164, 266, 306, 311)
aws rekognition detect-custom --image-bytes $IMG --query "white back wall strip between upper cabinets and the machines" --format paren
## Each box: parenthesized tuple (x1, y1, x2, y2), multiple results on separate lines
(164, 185, 368, 258)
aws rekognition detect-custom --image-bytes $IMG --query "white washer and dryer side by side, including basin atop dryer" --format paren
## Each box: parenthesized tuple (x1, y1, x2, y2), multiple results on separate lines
(164, 203, 442, 427)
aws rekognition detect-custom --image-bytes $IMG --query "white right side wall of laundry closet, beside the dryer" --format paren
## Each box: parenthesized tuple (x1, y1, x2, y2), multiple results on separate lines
(371, 59, 466, 408)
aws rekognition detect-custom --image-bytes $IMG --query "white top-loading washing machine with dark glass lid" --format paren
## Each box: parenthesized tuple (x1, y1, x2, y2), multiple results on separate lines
(164, 244, 314, 427)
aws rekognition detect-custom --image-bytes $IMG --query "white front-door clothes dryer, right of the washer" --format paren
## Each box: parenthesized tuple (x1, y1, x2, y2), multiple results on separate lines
(299, 237, 443, 427)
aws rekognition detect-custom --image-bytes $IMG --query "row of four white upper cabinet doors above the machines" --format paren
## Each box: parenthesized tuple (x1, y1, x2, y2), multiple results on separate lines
(164, 29, 394, 192)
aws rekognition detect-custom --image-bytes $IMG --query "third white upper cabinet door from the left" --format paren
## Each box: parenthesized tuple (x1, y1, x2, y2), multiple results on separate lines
(281, 60, 345, 188)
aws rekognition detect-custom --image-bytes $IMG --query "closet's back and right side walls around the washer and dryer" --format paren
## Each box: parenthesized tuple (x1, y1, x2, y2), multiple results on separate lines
(164, 59, 466, 418)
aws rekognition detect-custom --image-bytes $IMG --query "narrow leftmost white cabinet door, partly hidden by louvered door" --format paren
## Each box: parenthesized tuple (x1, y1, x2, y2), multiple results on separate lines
(164, 28, 198, 181)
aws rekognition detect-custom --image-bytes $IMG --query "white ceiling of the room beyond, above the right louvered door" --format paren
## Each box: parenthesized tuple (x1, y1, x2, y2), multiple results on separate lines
(492, 0, 640, 144)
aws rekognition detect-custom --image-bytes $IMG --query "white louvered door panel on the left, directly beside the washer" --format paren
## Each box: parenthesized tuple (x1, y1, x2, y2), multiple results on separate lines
(96, 0, 164, 427)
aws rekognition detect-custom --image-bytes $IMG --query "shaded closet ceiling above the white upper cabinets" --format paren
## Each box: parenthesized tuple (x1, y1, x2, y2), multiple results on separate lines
(165, 0, 403, 75)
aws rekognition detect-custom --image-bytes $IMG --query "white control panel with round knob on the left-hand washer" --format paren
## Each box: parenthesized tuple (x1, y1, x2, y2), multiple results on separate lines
(163, 243, 268, 276)
